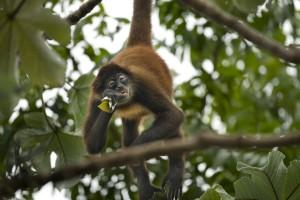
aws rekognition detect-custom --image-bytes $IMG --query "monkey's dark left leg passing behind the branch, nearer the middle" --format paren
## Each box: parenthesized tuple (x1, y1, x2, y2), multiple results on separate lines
(123, 119, 161, 200)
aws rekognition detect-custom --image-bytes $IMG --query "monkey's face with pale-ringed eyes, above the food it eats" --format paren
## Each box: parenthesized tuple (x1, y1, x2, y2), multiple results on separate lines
(101, 72, 133, 105)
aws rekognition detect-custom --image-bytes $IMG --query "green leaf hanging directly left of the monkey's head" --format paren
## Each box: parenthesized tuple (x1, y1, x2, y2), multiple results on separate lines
(69, 74, 95, 129)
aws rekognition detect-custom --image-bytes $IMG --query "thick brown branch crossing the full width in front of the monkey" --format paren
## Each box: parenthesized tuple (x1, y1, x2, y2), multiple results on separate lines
(0, 133, 300, 196)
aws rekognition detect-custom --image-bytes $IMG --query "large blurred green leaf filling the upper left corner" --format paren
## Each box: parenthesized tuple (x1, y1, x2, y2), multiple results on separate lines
(0, 0, 70, 86)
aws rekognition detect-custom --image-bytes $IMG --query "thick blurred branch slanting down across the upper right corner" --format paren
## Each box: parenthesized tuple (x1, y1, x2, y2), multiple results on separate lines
(181, 0, 300, 64)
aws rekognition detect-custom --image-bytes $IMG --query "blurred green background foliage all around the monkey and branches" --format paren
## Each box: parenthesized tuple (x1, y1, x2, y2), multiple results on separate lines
(0, 0, 300, 200)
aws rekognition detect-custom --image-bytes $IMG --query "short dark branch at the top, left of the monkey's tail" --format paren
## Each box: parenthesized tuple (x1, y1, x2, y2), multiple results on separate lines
(65, 0, 102, 25)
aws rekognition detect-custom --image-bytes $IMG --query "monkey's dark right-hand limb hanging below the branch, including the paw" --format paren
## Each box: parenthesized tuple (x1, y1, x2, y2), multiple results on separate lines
(162, 131, 184, 200)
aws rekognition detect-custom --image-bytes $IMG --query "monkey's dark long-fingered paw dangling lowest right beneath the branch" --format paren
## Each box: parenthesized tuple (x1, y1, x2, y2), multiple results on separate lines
(162, 167, 183, 200)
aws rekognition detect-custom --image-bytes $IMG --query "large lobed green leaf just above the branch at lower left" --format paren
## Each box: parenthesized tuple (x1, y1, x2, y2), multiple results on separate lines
(15, 128, 86, 172)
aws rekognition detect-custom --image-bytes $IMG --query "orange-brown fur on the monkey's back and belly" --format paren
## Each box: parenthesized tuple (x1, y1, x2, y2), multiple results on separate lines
(112, 46, 172, 119)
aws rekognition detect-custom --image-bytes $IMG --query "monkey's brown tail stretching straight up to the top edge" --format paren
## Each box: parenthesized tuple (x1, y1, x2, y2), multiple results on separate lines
(127, 0, 152, 47)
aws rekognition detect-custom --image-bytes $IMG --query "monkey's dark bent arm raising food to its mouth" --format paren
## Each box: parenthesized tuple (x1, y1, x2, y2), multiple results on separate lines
(84, 100, 112, 154)
